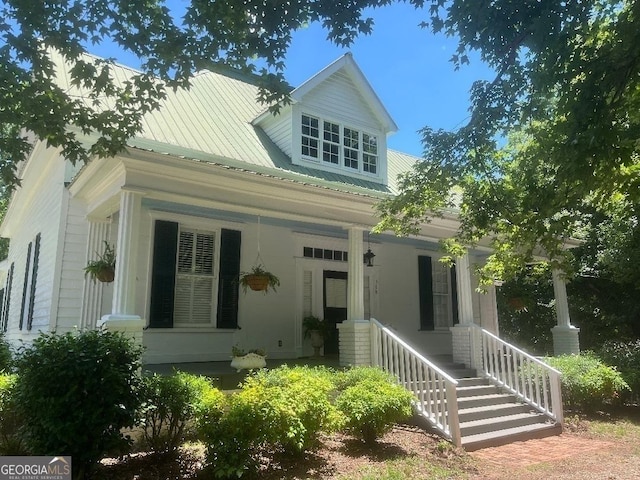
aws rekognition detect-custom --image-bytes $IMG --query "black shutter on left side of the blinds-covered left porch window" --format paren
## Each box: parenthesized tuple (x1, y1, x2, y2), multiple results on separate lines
(149, 220, 178, 328)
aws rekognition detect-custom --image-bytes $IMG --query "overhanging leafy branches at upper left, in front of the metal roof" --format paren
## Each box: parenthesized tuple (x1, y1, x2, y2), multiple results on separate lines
(0, 0, 430, 191)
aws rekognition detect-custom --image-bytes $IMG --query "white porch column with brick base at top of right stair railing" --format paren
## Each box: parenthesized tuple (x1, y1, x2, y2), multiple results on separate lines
(451, 254, 482, 368)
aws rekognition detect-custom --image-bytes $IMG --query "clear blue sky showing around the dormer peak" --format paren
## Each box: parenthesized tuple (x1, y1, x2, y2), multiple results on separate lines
(90, 0, 491, 156)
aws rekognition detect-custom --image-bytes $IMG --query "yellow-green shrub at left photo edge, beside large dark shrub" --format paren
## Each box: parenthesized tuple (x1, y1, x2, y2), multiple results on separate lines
(0, 374, 28, 455)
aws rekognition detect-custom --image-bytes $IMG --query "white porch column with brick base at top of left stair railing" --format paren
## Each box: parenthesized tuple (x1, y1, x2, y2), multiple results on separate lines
(338, 227, 371, 365)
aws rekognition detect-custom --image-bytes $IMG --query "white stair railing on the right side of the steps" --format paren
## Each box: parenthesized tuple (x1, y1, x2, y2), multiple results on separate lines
(471, 326, 563, 423)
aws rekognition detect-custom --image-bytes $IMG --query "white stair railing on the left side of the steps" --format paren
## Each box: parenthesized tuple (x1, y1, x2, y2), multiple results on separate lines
(371, 319, 461, 446)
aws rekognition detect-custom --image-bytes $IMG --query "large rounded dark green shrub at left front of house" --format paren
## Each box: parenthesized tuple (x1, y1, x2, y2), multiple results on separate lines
(15, 331, 142, 478)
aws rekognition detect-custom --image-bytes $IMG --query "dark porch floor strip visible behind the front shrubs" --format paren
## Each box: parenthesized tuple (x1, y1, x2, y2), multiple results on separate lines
(142, 355, 341, 390)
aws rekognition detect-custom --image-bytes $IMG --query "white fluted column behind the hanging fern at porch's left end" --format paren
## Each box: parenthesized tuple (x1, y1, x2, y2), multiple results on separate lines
(80, 218, 110, 329)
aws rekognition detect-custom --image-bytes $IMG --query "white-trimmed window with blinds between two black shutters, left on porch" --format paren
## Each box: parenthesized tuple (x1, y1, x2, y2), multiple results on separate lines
(174, 226, 217, 325)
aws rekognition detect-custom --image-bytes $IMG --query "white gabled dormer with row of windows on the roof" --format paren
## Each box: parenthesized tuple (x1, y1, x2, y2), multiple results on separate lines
(254, 53, 397, 185)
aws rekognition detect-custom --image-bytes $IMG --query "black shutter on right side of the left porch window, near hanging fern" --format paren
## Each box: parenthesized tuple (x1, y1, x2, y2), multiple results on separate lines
(217, 228, 242, 328)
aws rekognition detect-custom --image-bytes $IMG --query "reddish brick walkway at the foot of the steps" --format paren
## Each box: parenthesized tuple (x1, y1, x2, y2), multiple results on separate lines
(470, 434, 615, 468)
